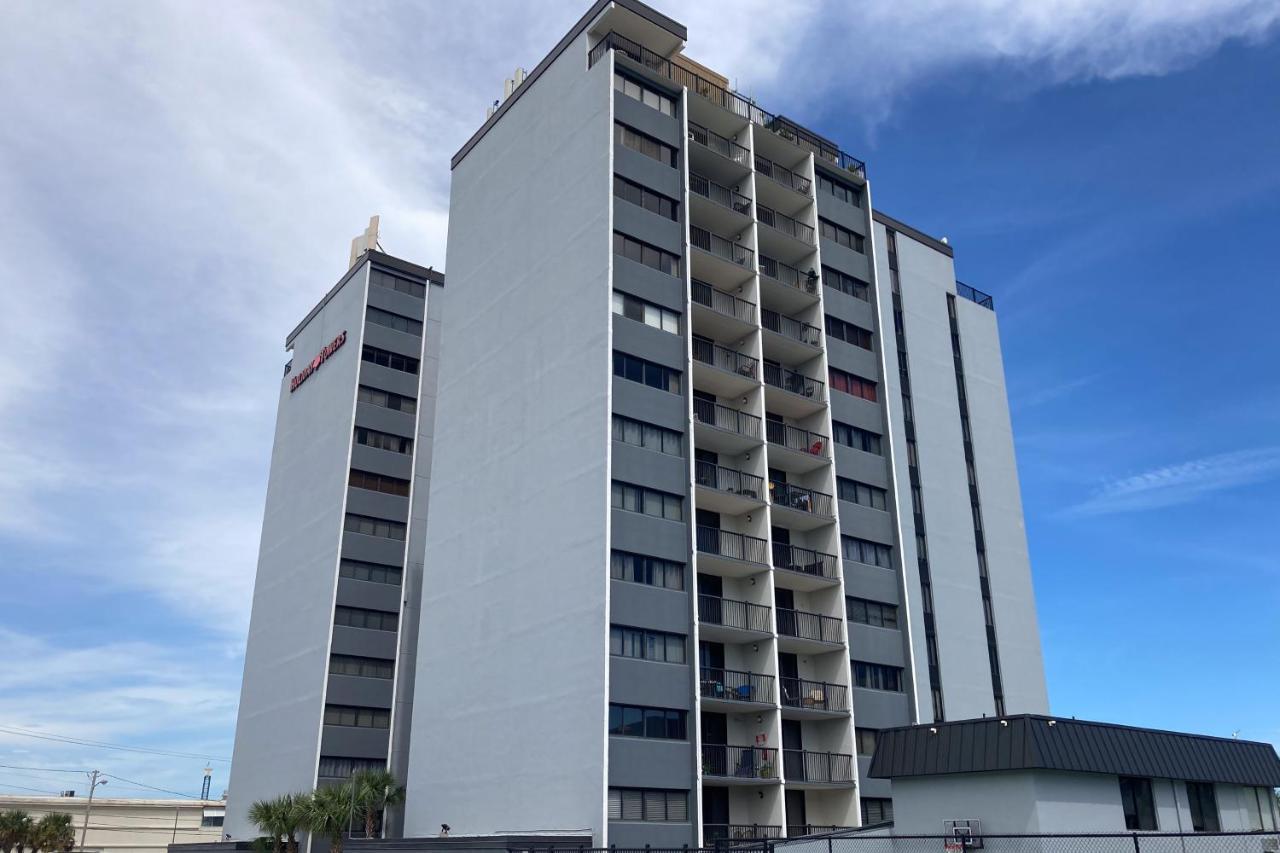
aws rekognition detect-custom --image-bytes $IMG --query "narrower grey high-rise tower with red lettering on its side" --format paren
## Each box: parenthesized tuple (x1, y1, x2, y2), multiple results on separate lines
(227, 250, 444, 839)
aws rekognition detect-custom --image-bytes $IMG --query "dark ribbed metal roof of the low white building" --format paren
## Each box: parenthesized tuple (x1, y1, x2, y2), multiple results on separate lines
(870, 715, 1280, 788)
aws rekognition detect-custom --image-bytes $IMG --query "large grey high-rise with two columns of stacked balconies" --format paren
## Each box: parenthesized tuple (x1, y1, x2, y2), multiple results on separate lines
(406, 0, 1047, 847)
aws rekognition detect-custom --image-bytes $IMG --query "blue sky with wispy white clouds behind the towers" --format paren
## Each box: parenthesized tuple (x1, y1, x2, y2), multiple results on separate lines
(0, 0, 1280, 795)
